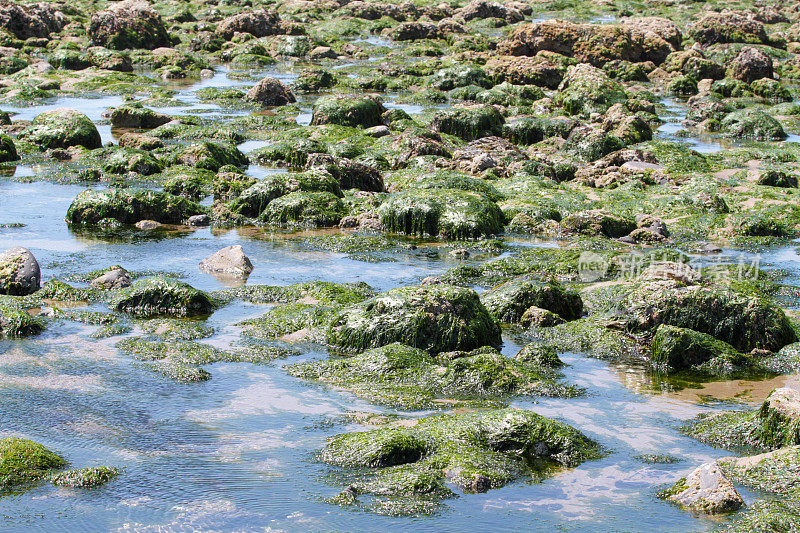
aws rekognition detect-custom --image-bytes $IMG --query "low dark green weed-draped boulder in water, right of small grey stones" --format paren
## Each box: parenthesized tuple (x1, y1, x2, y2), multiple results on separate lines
(111, 276, 213, 317)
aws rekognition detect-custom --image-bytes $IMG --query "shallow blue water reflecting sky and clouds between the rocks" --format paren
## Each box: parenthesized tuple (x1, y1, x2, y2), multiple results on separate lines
(0, 59, 800, 532)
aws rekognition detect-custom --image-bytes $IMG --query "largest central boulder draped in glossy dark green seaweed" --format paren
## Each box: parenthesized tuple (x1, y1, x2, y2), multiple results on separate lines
(327, 285, 500, 353)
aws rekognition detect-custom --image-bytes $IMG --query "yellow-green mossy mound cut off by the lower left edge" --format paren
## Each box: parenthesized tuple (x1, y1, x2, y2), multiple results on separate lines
(0, 437, 67, 488)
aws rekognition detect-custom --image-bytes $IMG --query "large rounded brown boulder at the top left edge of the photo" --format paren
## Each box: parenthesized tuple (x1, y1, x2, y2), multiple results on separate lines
(87, 0, 171, 50)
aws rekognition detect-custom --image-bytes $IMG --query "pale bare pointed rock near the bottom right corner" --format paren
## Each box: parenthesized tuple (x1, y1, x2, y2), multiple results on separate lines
(659, 461, 744, 514)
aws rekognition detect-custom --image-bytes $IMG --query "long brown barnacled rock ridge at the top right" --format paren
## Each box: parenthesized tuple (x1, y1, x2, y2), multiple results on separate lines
(497, 20, 673, 67)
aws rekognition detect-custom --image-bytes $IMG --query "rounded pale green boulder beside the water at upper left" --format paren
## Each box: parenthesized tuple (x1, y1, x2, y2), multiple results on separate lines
(20, 107, 102, 149)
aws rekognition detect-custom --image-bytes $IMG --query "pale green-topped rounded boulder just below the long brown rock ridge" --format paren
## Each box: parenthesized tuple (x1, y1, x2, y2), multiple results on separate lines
(555, 63, 627, 116)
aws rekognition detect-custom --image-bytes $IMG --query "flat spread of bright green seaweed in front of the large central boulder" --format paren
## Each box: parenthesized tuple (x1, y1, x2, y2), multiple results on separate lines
(289, 342, 581, 409)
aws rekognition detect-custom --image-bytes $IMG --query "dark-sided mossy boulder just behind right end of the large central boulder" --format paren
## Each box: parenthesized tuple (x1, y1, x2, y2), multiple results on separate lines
(481, 276, 583, 323)
